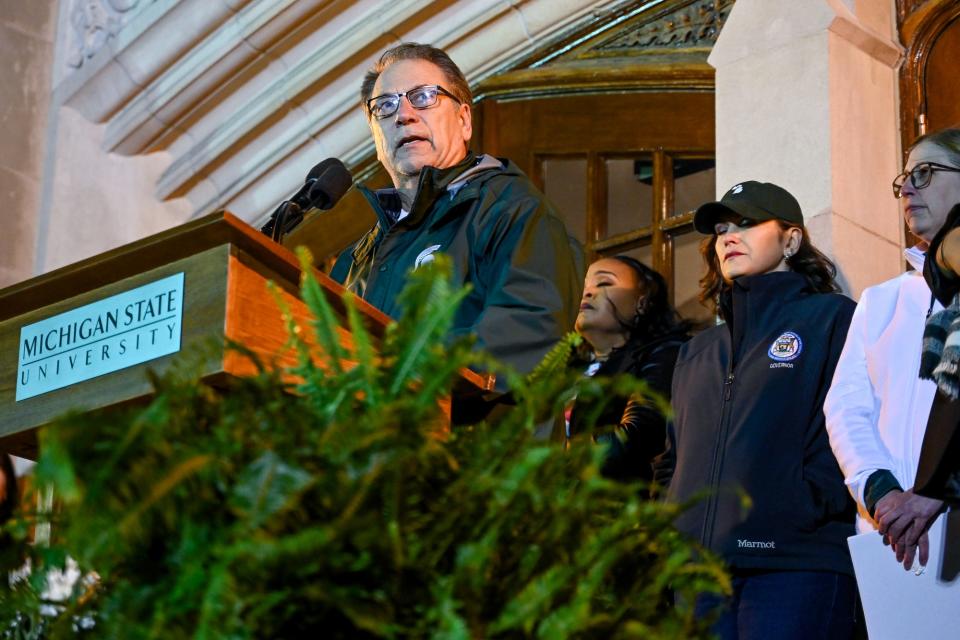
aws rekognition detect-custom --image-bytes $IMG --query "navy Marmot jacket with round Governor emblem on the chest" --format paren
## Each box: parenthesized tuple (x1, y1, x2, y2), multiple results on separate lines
(655, 271, 855, 575)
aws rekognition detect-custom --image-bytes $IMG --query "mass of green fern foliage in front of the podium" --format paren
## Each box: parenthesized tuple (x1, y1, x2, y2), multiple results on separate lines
(0, 255, 725, 640)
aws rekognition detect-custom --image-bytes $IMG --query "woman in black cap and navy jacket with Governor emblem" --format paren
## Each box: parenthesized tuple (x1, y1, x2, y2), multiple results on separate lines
(655, 182, 856, 640)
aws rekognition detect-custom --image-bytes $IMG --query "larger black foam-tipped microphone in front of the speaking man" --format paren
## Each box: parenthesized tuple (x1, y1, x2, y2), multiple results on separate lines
(260, 158, 353, 242)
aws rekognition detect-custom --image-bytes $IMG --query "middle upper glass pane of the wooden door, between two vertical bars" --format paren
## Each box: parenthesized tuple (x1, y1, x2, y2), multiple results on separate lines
(606, 158, 653, 238)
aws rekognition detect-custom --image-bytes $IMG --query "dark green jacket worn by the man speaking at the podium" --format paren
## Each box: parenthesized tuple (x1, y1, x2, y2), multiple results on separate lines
(331, 155, 583, 390)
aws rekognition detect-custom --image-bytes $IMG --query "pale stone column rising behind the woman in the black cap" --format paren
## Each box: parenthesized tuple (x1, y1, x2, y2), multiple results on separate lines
(709, 0, 903, 297)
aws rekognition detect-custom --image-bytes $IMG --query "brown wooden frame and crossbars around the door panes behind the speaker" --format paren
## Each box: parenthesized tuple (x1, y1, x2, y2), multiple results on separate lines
(475, 85, 715, 308)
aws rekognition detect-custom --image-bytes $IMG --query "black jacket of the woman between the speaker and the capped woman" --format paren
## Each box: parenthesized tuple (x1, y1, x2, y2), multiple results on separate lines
(570, 330, 690, 482)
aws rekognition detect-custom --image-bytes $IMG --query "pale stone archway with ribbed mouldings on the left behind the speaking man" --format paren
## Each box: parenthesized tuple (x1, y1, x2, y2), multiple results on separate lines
(20, 0, 628, 280)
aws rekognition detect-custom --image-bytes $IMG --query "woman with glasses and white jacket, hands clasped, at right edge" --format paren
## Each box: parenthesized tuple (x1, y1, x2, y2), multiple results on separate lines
(824, 128, 960, 568)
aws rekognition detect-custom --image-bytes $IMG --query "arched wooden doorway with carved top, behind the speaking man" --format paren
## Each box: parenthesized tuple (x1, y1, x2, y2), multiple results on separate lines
(296, 0, 733, 325)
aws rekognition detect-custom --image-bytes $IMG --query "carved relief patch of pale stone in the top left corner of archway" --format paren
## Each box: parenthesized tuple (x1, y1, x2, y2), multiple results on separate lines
(66, 0, 155, 69)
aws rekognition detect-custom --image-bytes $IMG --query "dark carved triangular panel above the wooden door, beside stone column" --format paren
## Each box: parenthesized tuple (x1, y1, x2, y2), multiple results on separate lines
(593, 0, 734, 53)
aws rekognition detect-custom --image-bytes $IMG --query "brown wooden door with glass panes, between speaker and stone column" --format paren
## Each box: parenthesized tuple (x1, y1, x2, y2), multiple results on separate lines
(477, 91, 716, 325)
